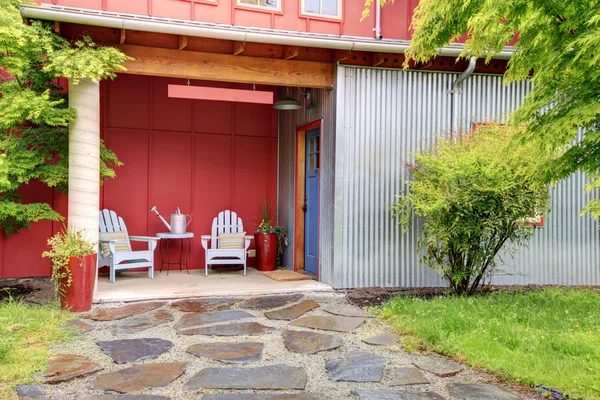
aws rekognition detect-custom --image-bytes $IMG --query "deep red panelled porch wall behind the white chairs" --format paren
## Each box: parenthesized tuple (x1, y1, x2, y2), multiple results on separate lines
(102, 75, 277, 268)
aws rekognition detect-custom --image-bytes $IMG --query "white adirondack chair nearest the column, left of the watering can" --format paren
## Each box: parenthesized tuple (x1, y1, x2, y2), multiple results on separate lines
(98, 209, 160, 283)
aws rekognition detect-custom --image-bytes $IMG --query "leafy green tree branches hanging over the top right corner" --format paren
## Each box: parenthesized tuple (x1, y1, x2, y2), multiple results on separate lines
(363, 0, 600, 218)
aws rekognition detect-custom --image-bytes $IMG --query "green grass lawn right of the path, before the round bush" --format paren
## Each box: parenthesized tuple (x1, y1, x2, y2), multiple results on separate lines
(381, 288, 600, 399)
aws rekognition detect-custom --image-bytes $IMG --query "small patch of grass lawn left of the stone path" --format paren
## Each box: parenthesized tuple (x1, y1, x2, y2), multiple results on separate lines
(0, 300, 72, 399)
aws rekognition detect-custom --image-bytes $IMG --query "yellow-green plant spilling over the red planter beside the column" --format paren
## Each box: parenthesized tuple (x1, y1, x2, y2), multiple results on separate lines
(42, 228, 96, 295)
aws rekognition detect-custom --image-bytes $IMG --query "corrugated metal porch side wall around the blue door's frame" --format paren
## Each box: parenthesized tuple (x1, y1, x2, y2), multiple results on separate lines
(278, 83, 335, 284)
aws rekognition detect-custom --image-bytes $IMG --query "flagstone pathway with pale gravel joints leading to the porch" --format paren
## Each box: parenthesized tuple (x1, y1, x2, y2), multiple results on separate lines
(17, 294, 533, 400)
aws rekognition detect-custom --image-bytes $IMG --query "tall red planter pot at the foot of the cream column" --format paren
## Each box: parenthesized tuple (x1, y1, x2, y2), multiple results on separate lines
(60, 254, 97, 312)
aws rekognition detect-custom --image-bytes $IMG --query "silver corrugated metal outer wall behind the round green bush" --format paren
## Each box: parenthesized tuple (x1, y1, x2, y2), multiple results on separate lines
(332, 67, 600, 287)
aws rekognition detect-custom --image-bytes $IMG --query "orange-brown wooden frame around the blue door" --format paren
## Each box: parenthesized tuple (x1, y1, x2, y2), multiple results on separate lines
(293, 119, 323, 275)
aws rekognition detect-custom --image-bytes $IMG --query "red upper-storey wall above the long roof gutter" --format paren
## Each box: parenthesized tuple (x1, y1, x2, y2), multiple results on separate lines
(40, 0, 418, 40)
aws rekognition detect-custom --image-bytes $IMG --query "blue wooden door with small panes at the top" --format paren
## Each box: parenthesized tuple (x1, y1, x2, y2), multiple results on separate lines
(304, 128, 321, 274)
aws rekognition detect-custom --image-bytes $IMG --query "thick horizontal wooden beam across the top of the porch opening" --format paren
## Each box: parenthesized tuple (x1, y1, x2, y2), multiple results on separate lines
(113, 45, 333, 88)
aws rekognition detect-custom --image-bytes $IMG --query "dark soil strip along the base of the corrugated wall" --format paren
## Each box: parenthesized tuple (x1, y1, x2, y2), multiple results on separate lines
(347, 285, 600, 307)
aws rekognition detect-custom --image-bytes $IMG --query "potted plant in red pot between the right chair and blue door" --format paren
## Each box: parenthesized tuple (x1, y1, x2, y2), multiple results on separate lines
(254, 202, 287, 271)
